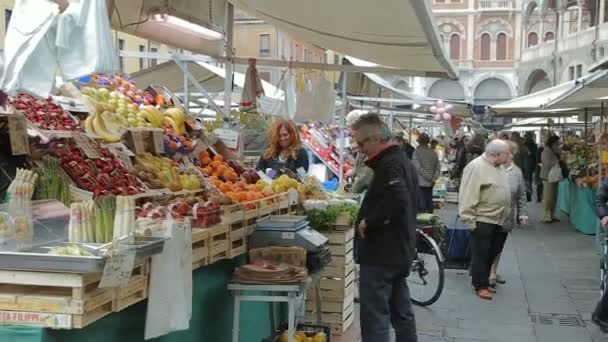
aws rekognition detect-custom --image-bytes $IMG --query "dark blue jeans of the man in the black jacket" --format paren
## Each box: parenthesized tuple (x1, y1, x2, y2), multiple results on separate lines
(359, 264, 417, 342)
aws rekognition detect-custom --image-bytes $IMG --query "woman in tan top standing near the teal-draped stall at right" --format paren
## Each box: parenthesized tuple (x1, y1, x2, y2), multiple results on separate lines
(540, 135, 564, 223)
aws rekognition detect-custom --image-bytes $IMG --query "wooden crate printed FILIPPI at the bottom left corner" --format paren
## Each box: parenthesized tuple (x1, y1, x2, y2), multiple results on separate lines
(0, 270, 115, 329)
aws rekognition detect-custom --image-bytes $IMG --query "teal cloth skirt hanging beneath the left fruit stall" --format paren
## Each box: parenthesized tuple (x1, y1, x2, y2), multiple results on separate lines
(0, 257, 272, 342)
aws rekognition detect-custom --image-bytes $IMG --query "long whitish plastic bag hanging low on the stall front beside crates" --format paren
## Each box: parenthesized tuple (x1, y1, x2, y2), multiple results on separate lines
(145, 220, 192, 340)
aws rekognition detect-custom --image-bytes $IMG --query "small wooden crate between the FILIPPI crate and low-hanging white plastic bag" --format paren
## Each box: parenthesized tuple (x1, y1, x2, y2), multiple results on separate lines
(112, 260, 150, 312)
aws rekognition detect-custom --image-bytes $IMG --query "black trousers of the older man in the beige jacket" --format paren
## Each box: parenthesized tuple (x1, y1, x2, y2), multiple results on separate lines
(471, 222, 502, 290)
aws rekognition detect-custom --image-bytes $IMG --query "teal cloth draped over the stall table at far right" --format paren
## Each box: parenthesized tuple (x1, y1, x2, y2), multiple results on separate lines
(557, 179, 599, 235)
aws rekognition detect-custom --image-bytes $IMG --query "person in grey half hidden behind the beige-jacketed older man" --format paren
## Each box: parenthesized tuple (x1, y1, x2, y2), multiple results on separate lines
(489, 141, 528, 288)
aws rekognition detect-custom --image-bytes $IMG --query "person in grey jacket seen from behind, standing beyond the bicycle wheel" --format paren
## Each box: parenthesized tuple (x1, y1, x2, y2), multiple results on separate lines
(412, 133, 441, 213)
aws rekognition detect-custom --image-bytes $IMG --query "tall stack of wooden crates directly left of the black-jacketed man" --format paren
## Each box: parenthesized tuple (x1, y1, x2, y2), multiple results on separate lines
(306, 226, 356, 335)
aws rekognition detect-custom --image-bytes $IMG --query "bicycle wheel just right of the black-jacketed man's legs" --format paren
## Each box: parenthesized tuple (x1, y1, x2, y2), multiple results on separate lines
(407, 230, 445, 306)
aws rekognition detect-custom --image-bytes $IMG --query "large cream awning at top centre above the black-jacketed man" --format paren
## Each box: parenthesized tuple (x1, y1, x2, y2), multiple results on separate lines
(230, 0, 457, 78)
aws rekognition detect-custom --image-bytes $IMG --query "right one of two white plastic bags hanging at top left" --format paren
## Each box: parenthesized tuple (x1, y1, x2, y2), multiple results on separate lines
(55, 0, 119, 80)
